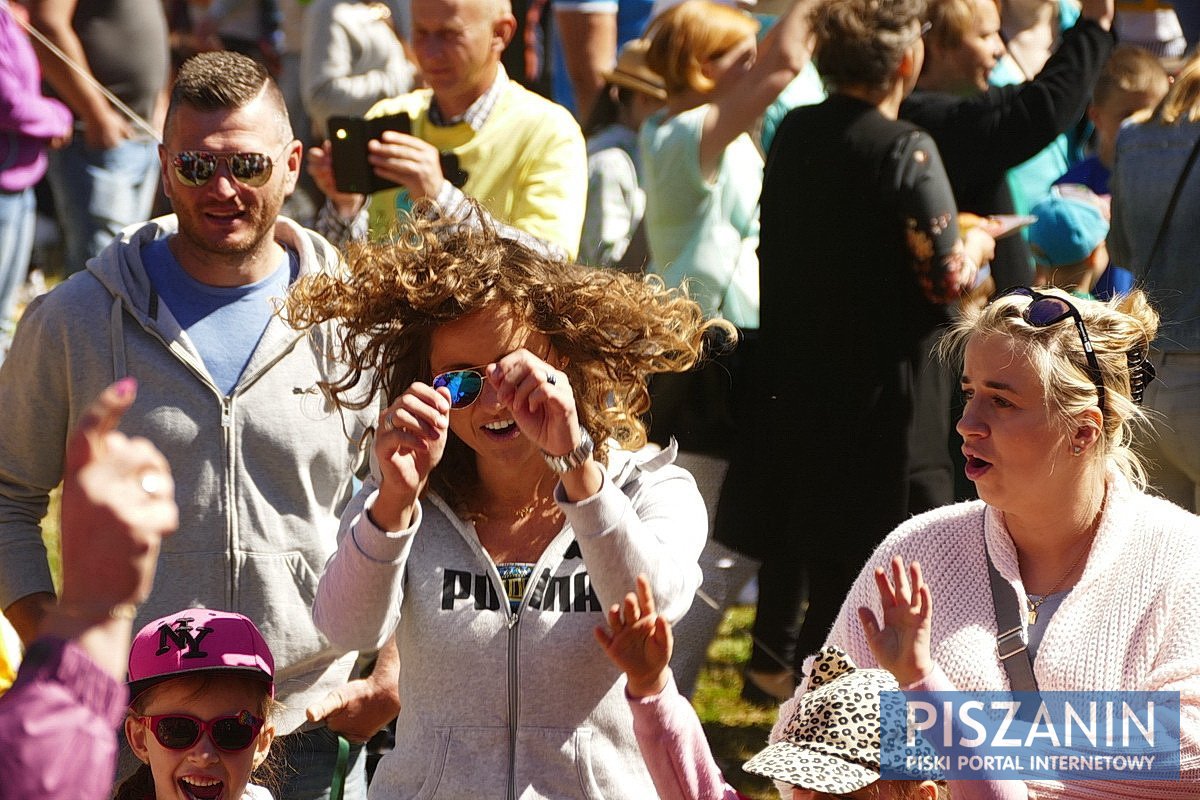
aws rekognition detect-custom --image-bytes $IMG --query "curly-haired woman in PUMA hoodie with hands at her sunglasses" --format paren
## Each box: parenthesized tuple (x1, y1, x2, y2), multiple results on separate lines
(289, 208, 727, 798)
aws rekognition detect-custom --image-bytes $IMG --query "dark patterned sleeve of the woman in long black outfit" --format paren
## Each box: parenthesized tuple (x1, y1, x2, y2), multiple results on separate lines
(892, 131, 965, 305)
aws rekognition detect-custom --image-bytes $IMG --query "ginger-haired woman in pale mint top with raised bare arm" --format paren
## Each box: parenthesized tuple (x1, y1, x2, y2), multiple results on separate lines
(638, 0, 809, 330)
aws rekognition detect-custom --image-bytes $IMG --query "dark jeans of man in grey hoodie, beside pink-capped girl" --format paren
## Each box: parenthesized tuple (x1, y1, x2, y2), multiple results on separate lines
(271, 726, 367, 800)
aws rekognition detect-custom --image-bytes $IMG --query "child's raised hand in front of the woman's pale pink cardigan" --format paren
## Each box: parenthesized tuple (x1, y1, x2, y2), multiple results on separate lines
(858, 555, 934, 686)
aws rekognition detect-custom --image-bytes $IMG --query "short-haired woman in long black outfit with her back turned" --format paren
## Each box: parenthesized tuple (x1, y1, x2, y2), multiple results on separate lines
(716, 0, 992, 699)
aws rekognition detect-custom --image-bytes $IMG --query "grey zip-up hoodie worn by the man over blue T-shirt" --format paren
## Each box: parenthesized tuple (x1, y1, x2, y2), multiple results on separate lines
(0, 216, 378, 734)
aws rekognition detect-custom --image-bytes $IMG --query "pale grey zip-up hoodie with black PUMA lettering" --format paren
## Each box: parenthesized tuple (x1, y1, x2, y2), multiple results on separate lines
(313, 446, 708, 800)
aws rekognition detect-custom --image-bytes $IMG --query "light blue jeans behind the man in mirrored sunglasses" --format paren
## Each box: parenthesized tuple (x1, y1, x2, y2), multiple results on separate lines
(47, 130, 158, 275)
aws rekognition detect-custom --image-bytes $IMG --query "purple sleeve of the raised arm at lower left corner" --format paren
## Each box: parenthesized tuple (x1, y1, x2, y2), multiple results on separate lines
(0, 638, 128, 800)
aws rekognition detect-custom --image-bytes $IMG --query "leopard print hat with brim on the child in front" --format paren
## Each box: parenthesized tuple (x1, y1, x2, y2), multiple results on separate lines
(743, 646, 932, 794)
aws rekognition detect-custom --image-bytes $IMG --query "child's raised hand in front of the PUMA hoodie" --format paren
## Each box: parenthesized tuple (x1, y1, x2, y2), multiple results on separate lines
(595, 575, 673, 697)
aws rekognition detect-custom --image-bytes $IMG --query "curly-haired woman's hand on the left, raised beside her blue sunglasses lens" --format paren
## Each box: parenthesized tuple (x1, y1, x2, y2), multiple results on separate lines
(370, 383, 450, 530)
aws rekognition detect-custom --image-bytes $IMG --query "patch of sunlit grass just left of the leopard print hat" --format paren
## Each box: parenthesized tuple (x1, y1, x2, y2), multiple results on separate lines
(692, 606, 779, 800)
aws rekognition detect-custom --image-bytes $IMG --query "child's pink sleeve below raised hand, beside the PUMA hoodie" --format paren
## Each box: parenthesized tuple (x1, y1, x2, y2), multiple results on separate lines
(625, 676, 743, 800)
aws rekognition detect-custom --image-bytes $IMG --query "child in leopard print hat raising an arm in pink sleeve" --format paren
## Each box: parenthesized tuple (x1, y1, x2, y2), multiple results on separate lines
(595, 576, 1026, 800)
